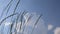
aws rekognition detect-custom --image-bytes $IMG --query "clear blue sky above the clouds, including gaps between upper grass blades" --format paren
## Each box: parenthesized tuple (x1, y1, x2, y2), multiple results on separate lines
(0, 0, 60, 33)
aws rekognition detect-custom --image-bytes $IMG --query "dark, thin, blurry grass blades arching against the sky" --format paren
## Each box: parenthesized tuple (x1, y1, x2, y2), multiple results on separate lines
(0, 0, 42, 34)
